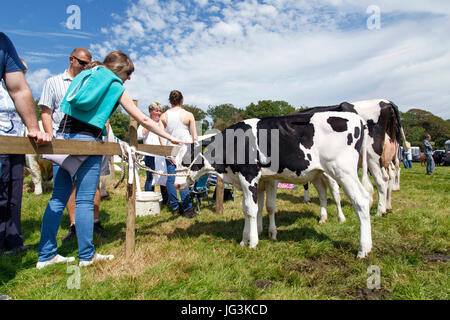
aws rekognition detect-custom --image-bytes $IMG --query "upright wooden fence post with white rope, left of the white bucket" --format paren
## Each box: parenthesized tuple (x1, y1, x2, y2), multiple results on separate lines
(125, 100, 139, 258)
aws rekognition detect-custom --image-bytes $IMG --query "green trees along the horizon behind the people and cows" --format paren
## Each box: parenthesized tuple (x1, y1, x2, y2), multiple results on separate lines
(35, 100, 450, 149)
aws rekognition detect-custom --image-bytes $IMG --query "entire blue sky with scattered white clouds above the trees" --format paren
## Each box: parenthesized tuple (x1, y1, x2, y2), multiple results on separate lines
(0, 0, 450, 119)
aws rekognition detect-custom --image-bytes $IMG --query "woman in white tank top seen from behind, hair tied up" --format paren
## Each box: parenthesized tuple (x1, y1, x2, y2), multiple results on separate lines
(161, 90, 198, 219)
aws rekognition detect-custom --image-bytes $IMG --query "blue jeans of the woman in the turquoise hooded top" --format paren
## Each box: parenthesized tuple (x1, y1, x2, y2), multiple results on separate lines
(38, 133, 102, 262)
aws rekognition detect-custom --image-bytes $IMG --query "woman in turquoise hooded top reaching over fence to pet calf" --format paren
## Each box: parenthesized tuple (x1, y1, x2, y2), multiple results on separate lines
(36, 51, 181, 269)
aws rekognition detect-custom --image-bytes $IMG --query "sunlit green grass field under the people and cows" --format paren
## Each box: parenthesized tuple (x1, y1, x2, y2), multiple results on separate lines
(0, 164, 450, 300)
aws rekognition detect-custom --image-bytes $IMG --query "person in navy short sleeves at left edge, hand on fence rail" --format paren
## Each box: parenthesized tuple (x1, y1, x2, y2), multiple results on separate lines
(0, 32, 52, 254)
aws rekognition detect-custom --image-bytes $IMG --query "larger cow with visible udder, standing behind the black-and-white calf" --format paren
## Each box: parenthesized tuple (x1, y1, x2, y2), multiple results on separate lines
(264, 99, 410, 228)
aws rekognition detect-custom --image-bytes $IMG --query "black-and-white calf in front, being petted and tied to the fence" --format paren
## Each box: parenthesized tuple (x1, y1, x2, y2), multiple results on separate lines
(174, 112, 372, 258)
